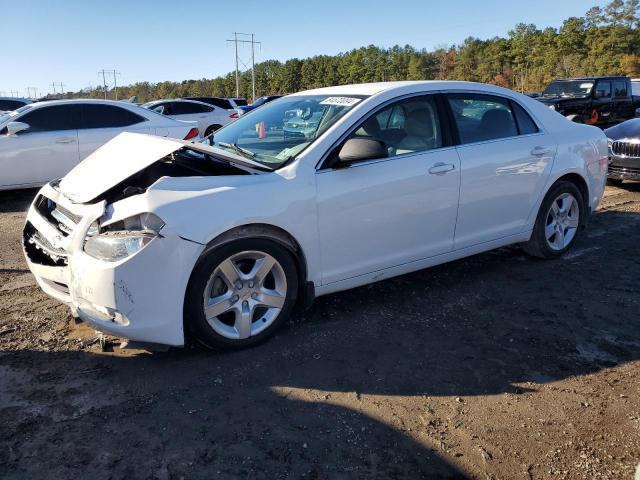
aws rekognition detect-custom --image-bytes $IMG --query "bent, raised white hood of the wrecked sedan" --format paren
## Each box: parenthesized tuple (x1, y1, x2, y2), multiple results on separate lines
(58, 133, 268, 203)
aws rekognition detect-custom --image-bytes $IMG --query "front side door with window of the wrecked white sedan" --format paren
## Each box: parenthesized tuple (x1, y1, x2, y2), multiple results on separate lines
(316, 95, 460, 284)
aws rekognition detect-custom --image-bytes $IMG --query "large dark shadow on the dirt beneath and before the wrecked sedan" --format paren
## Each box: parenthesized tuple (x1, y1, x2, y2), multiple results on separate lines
(0, 205, 640, 479)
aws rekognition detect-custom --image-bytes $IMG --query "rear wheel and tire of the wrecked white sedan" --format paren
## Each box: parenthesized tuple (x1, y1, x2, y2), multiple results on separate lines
(522, 181, 586, 259)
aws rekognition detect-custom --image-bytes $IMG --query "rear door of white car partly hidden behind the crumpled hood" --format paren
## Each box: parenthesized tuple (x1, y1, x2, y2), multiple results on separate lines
(78, 103, 154, 160)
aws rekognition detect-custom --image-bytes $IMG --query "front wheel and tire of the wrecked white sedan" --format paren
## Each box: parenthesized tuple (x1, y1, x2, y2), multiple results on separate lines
(184, 238, 298, 349)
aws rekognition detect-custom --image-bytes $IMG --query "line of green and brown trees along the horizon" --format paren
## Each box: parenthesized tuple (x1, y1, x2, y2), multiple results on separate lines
(61, 0, 640, 102)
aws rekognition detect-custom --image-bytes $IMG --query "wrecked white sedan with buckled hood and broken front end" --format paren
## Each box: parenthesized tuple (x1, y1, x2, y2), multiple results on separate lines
(23, 82, 608, 348)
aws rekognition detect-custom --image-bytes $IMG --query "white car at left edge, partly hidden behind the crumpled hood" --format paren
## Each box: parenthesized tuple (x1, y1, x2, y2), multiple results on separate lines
(0, 100, 199, 190)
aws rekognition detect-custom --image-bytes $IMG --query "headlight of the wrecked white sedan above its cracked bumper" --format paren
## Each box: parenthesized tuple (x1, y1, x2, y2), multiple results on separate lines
(84, 213, 164, 262)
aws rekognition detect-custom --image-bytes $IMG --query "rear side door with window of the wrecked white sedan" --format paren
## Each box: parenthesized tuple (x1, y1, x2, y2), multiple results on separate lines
(447, 93, 556, 249)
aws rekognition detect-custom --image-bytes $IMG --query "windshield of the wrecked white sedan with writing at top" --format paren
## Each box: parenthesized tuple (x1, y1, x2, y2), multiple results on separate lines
(203, 95, 365, 169)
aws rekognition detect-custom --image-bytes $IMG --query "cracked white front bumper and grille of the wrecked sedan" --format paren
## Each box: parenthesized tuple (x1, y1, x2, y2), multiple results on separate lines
(23, 185, 203, 346)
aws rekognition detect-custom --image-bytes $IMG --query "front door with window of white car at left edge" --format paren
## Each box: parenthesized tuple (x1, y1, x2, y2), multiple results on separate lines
(0, 104, 80, 186)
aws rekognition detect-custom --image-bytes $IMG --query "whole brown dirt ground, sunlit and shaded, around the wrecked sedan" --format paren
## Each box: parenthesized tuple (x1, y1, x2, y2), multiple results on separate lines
(0, 184, 640, 480)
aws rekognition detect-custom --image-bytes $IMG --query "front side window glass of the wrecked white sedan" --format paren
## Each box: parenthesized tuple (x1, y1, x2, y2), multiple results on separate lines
(349, 95, 443, 157)
